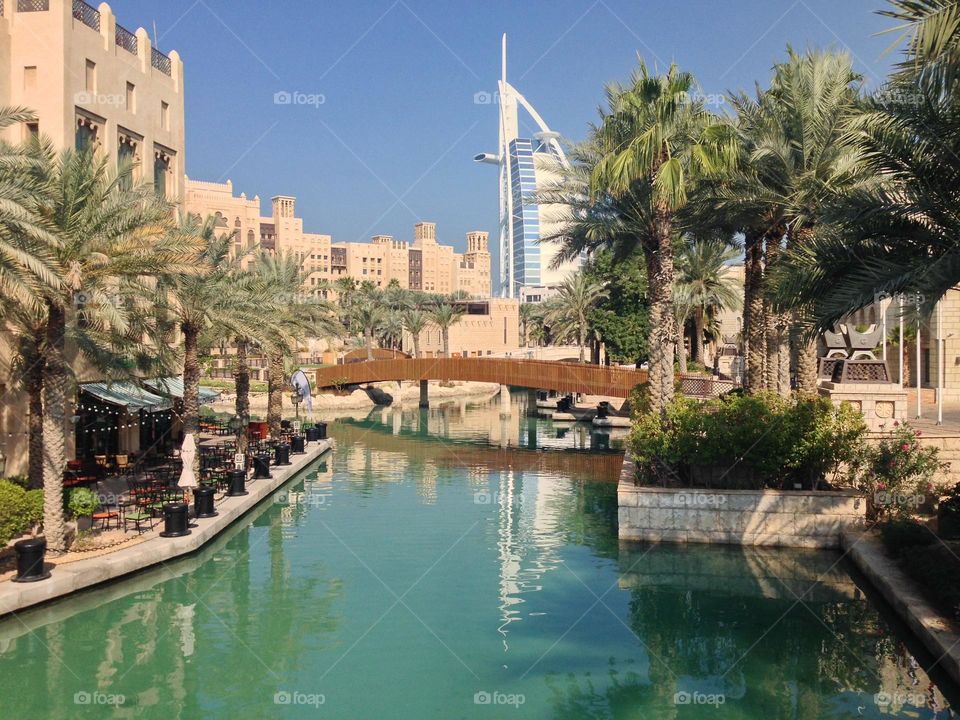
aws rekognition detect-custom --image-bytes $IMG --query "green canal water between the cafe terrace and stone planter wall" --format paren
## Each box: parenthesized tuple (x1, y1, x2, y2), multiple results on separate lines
(0, 404, 956, 720)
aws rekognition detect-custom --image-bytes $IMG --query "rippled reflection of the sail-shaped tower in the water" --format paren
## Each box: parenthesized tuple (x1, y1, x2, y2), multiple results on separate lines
(493, 470, 569, 651)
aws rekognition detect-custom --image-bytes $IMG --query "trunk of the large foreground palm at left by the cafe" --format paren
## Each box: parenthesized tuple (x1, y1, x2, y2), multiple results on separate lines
(43, 303, 69, 554)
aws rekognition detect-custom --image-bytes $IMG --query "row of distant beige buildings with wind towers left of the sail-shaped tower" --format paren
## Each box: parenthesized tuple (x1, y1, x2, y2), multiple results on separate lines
(184, 178, 491, 298)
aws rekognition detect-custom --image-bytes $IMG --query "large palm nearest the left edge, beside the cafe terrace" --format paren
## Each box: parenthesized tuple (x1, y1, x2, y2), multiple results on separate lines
(29, 146, 192, 553)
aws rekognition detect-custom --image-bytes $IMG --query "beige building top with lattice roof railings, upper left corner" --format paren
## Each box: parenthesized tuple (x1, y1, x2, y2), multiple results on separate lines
(0, 0, 185, 200)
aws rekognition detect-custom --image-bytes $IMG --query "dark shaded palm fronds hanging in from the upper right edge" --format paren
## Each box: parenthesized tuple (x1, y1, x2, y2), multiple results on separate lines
(778, 12, 960, 329)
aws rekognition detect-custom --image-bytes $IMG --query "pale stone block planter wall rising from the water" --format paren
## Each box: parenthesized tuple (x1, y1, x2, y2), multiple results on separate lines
(617, 453, 866, 548)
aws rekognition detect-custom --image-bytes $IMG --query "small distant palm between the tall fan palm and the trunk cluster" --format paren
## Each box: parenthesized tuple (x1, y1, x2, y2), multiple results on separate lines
(677, 238, 741, 365)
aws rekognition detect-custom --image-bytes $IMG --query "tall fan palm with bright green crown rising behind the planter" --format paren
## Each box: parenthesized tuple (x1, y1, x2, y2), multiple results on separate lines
(589, 62, 736, 411)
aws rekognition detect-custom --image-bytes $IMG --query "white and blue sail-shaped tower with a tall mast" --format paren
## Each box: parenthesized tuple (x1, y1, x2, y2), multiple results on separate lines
(474, 35, 577, 301)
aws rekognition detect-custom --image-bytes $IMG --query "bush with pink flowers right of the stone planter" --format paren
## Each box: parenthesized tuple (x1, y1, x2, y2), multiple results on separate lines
(861, 423, 947, 519)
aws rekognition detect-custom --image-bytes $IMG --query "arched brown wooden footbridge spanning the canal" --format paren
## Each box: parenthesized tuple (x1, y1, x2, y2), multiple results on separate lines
(316, 358, 647, 397)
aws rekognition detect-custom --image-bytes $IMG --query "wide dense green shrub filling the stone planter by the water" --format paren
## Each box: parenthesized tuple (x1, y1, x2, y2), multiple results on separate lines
(628, 393, 866, 489)
